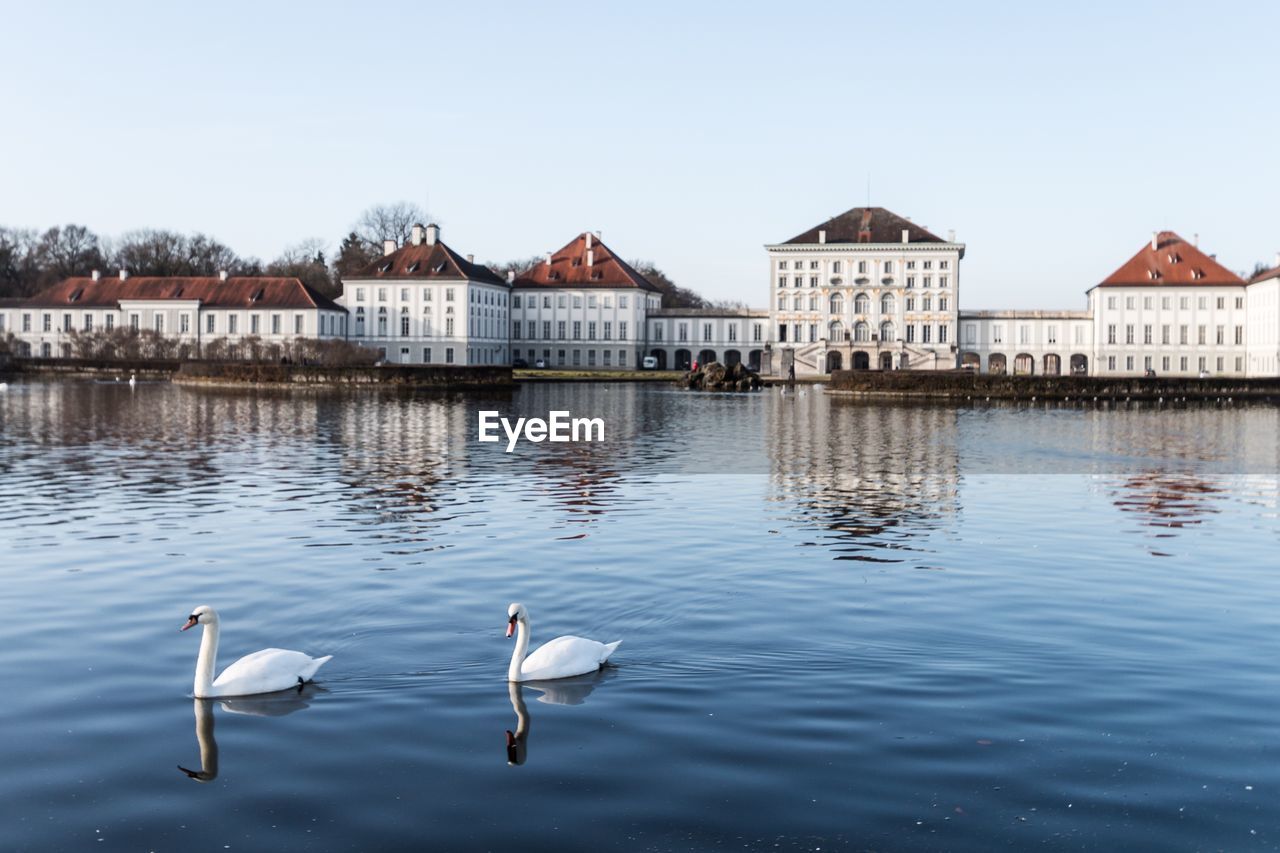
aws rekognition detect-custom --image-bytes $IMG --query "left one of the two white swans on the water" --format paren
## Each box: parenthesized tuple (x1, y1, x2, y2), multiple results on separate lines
(182, 605, 333, 699)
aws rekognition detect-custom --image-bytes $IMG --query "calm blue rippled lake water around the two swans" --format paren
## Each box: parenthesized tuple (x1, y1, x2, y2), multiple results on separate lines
(0, 382, 1280, 850)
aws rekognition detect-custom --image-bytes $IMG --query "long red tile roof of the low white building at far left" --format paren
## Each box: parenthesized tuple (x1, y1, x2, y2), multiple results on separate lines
(18, 275, 346, 311)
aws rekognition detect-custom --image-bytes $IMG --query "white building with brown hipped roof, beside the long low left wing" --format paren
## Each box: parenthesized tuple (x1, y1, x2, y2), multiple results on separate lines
(337, 225, 511, 365)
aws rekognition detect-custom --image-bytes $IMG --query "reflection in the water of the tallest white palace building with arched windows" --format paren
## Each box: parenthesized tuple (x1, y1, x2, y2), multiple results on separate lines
(768, 393, 960, 562)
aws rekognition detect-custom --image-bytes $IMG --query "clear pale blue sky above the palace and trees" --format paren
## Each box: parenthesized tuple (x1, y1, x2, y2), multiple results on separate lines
(0, 0, 1280, 310)
